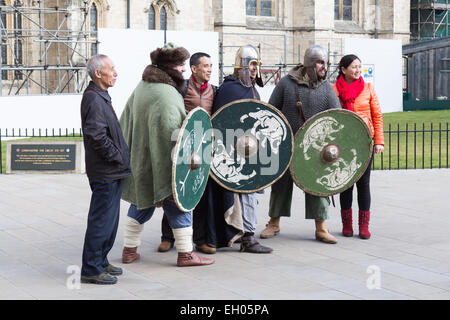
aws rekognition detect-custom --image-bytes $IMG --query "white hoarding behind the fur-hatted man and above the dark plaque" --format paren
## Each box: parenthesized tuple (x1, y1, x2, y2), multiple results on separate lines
(0, 29, 219, 133)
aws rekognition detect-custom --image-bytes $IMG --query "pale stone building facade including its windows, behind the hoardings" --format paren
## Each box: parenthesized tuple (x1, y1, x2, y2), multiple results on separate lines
(0, 0, 410, 94)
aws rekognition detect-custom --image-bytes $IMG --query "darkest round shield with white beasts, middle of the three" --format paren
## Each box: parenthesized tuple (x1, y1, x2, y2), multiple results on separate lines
(211, 99, 294, 193)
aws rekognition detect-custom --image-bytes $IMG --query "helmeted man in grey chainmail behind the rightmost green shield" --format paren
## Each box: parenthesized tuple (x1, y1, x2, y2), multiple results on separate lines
(260, 45, 341, 243)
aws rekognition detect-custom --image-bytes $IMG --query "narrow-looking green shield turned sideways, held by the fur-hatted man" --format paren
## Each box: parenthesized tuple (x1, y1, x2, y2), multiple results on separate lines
(172, 107, 213, 212)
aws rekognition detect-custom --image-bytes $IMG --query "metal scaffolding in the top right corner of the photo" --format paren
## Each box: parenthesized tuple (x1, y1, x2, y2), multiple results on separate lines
(410, 0, 450, 41)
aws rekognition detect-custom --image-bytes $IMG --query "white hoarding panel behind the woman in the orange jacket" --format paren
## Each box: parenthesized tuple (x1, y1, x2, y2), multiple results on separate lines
(344, 38, 403, 113)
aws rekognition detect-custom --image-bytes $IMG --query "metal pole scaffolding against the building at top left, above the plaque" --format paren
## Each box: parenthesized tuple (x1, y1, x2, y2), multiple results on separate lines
(0, 0, 97, 95)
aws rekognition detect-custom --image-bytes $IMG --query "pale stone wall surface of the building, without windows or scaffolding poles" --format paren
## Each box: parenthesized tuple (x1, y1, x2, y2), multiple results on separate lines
(3, 0, 410, 94)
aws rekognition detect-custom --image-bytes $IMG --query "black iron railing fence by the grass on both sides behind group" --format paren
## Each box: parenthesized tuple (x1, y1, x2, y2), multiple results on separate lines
(0, 122, 450, 173)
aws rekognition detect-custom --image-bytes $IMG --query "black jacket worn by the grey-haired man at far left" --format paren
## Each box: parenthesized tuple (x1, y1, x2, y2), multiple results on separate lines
(81, 81, 131, 180)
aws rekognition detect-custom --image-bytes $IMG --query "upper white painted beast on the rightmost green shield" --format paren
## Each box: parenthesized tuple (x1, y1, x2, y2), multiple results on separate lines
(300, 117, 344, 160)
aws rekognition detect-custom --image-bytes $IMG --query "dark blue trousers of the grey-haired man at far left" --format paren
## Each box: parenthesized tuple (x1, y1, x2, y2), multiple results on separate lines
(81, 180, 122, 276)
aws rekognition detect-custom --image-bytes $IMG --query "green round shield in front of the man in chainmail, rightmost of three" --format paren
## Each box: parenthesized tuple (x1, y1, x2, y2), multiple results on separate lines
(290, 109, 373, 196)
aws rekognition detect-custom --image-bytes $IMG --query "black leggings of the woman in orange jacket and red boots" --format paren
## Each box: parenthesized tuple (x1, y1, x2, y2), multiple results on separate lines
(339, 154, 373, 211)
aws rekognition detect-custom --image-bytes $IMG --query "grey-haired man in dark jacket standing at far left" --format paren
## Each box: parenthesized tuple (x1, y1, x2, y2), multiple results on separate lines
(81, 55, 131, 284)
